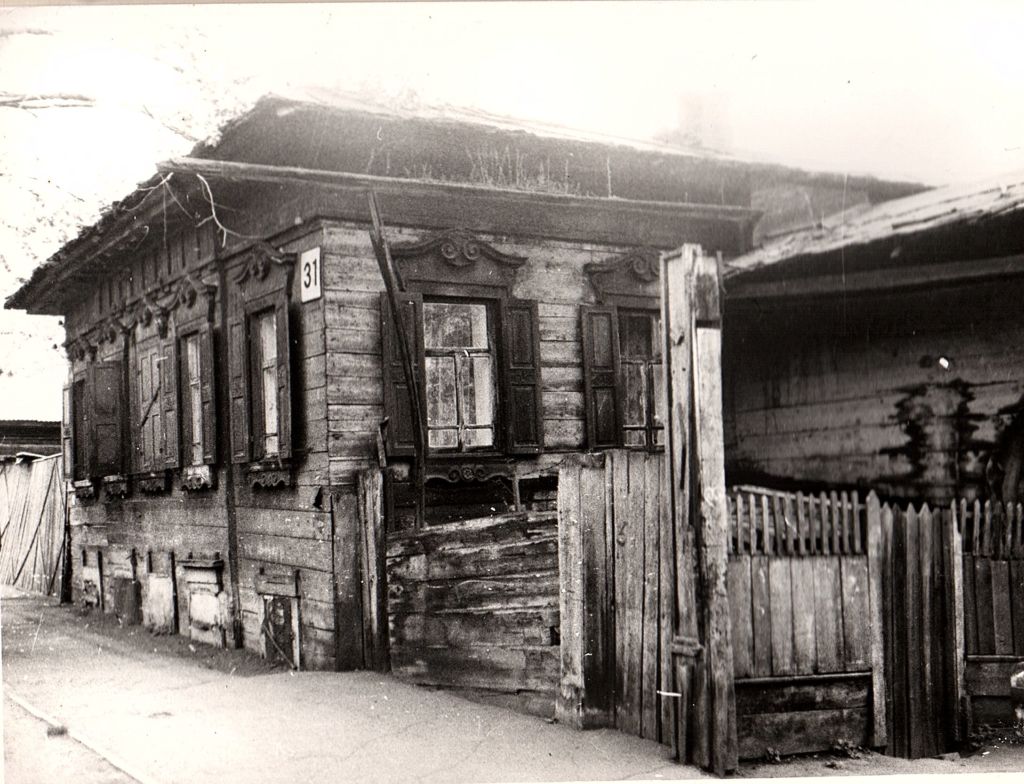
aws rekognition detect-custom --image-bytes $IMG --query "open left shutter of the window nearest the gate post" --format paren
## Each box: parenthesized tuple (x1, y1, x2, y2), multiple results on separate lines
(581, 306, 622, 449)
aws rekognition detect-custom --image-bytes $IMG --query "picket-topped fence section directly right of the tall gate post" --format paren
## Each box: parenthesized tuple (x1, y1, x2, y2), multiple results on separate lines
(728, 487, 886, 757)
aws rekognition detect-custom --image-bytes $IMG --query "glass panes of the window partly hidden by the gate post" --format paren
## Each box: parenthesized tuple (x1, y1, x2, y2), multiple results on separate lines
(618, 310, 665, 448)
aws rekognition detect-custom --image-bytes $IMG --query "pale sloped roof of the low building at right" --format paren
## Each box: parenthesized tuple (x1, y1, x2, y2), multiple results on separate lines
(724, 171, 1024, 278)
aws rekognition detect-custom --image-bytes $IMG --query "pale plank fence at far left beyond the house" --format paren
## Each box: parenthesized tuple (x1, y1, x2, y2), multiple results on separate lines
(0, 455, 67, 596)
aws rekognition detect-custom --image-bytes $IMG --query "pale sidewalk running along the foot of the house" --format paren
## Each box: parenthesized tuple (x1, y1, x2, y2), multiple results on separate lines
(0, 587, 701, 784)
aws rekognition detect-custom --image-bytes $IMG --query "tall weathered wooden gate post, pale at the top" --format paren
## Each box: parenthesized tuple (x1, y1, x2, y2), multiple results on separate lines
(662, 245, 738, 775)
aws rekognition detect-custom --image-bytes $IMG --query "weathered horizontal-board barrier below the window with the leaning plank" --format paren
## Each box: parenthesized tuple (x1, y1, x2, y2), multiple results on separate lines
(386, 512, 560, 716)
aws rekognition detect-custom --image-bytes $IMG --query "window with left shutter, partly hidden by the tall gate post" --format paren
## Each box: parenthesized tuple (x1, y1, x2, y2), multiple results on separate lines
(582, 306, 665, 449)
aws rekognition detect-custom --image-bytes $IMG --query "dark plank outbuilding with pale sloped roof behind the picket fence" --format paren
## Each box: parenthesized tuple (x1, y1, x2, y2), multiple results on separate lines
(724, 175, 1024, 504)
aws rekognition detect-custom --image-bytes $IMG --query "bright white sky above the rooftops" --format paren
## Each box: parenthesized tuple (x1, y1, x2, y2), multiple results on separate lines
(0, 2, 1024, 418)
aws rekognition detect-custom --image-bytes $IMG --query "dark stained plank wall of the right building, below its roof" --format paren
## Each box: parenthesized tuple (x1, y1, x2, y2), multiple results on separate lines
(723, 279, 1024, 504)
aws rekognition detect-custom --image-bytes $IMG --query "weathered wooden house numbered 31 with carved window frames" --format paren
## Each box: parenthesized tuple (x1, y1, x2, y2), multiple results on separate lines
(7, 93, 919, 773)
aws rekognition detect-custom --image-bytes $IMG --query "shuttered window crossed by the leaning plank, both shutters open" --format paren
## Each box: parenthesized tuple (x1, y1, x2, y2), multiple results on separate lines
(381, 293, 543, 456)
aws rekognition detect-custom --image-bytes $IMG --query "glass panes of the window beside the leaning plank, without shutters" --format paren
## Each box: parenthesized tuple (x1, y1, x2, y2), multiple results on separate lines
(423, 302, 495, 451)
